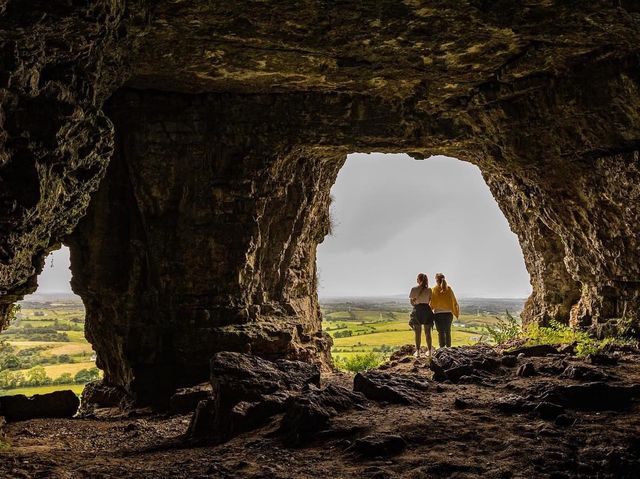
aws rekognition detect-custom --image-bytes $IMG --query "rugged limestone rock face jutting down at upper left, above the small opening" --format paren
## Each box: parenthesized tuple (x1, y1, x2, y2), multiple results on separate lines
(0, 0, 145, 327)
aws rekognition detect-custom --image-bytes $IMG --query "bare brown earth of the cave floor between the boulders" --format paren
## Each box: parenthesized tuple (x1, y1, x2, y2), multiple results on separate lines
(0, 353, 640, 479)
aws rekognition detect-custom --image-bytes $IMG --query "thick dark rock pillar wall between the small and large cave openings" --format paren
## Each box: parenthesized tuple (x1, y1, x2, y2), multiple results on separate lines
(67, 90, 345, 403)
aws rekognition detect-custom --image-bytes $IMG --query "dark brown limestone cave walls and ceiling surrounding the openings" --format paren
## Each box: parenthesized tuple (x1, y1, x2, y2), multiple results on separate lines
(0, 0, 640, 476)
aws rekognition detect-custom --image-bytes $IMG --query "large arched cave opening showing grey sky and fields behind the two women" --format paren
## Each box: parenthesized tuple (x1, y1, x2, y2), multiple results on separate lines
(317, 153, 531, 369)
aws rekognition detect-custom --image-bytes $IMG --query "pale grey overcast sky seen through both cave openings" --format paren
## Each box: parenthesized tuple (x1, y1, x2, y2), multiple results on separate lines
(31, 153, 531, 298)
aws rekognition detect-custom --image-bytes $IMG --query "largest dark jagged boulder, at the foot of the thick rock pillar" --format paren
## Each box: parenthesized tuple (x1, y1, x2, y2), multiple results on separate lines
(187, 351, 320, 443)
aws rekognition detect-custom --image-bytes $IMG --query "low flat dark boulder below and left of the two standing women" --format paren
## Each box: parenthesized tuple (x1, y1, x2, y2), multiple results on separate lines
(353, 371, 429, 405)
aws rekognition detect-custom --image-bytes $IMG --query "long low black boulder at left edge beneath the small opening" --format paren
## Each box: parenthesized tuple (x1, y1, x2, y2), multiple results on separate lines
(0, 390, 80, 422)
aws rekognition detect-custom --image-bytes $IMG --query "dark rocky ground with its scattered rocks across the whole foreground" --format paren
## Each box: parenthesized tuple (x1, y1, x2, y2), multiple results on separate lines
(0, 347, 640, 478)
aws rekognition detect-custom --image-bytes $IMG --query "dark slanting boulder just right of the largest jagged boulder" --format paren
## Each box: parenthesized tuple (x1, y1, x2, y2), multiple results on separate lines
(279, 384, 365, 446)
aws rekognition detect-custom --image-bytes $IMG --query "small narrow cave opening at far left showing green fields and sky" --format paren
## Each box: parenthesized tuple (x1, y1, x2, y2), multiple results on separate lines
(0, 246, 100, 396)
